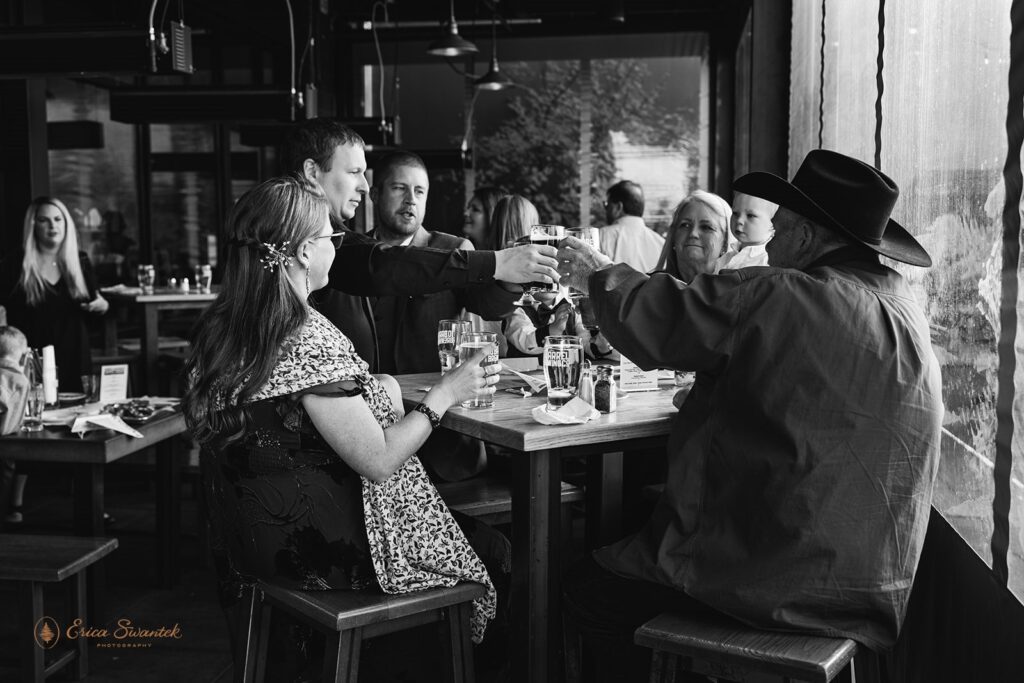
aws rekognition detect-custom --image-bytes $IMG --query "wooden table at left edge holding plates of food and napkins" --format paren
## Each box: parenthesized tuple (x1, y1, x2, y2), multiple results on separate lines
(0, 409, 185, 615)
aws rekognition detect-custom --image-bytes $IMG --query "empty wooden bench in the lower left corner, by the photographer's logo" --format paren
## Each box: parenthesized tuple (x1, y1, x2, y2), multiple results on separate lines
(0, 533, 118, 683)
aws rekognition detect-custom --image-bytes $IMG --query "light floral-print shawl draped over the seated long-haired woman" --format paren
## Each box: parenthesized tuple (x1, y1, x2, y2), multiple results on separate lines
(224, 310, 497, 642)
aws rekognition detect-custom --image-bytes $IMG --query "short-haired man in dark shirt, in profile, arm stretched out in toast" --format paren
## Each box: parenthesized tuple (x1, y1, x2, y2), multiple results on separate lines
(282, 118, 558, 372)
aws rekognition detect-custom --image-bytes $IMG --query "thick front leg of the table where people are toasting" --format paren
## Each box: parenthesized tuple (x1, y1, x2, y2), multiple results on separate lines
(512, 451, 561, 683)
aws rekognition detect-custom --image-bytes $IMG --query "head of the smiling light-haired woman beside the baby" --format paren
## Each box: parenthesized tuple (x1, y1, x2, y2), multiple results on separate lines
(657, 189, 732, 283)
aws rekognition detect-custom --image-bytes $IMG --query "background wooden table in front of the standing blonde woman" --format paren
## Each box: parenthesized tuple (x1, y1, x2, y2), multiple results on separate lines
(103, 287, 217, 394)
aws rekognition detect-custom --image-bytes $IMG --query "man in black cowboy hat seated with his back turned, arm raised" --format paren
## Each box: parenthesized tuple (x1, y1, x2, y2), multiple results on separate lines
(559, 150, 942, 680)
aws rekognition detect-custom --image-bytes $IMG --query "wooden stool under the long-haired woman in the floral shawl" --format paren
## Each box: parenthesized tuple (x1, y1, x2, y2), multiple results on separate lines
(234, 582, 486, 683)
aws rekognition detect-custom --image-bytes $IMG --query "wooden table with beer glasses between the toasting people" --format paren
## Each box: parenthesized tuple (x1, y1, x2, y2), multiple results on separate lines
(396, 373, 678, 683)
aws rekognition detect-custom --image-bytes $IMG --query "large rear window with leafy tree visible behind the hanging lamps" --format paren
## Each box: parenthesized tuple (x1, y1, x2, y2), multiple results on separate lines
(360, 35, 708, 237)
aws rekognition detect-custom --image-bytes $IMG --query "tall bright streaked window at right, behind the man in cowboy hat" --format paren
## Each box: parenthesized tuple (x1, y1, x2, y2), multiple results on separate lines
(790, 0, 1024, 598)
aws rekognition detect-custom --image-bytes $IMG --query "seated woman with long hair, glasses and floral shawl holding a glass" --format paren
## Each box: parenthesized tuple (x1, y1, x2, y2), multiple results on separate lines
(182, 176, 508, 680)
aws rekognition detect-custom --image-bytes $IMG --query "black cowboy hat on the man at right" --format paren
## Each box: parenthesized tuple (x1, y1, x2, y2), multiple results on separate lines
(732, 150, 932, 267)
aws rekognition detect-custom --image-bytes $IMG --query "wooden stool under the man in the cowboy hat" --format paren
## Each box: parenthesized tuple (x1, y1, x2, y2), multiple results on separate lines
(634, 612, 878, 683)
